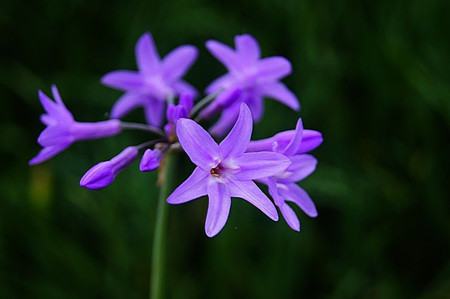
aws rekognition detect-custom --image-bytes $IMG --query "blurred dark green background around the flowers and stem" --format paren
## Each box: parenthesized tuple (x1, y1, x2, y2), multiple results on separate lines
(0, 0, 450, 299)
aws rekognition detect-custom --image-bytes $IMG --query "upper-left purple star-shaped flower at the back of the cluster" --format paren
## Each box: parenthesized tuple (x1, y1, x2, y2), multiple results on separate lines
(102, 33, 197, 126)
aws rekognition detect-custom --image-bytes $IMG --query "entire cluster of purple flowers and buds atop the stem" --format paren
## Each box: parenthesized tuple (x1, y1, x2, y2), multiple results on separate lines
(29, 33, 322, 237)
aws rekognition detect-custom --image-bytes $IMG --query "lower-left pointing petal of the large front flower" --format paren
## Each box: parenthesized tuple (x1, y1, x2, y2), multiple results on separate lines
(167, 167, 209, 204)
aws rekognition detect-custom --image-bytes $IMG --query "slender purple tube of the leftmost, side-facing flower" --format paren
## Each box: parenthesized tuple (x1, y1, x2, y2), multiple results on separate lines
(71, 119, 121, 140)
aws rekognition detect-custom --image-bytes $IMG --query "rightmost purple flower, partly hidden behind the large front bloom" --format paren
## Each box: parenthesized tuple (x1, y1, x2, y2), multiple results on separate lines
(253, 119, 322, 231)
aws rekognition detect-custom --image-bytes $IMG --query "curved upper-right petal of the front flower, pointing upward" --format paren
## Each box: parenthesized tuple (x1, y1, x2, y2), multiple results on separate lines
(219, 104, 253, 159)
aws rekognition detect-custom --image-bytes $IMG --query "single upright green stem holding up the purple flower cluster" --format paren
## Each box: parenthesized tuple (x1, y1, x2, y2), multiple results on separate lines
(149, 150, 176, 299)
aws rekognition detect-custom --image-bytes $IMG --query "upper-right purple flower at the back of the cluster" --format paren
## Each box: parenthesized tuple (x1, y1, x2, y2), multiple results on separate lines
(201, 34, 300, 134)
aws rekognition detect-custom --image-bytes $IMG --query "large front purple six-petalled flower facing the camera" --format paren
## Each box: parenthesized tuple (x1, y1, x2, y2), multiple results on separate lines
(167, 104, 290, 237)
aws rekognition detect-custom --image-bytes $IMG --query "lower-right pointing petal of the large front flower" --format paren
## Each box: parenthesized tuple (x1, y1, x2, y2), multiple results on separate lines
(228, 180, 278, 221)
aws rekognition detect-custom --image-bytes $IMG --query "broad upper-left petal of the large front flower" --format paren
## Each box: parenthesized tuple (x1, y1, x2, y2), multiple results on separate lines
(176, 118, 219, 171)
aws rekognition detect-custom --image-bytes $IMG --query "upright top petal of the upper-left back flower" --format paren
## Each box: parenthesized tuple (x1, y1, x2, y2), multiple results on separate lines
(135, 33, 160, 74)
